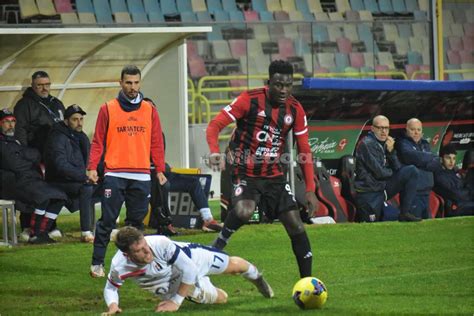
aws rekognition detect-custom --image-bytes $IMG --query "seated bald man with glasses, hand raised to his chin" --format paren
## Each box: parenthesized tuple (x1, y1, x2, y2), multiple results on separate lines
(355, 115, 420, 222)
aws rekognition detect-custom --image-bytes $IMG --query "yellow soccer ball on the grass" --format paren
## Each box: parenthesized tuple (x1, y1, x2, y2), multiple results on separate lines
(293, 277, 328, 309)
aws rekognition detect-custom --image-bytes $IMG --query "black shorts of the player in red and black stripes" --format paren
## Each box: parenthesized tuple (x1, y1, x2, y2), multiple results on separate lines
(232, 176, 298, 220)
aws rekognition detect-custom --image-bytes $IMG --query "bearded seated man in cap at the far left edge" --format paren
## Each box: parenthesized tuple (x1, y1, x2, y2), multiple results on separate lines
(0, 109, 67, 244)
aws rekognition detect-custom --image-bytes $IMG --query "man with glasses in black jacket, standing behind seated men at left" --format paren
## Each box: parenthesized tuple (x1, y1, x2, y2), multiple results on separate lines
(14, 70, 65, 155)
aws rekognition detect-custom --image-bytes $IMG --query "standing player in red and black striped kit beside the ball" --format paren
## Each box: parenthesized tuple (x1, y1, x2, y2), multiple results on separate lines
(206, 60, 318, 277)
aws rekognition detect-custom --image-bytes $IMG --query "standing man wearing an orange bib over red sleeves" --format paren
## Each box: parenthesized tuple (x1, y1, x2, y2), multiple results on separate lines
(87, 65, 166, 277)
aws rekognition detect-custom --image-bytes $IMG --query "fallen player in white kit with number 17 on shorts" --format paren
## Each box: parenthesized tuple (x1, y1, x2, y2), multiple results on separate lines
(103, 226, 273, 315)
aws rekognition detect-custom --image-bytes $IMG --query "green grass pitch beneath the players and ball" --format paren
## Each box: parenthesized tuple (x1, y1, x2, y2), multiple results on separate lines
(0, 203, 474, 316)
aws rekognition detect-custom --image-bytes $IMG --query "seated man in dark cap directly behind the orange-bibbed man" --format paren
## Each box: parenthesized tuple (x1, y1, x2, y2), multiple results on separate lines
(44, 104, 94, 243)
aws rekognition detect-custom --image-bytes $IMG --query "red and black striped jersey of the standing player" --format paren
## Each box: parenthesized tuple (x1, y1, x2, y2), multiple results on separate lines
(223, 87, 308, 177)
